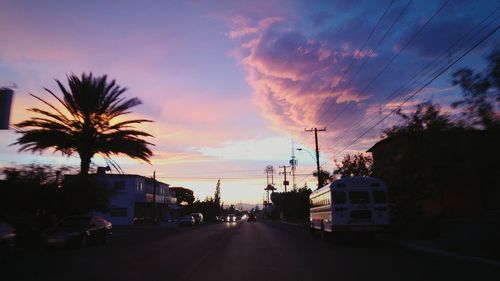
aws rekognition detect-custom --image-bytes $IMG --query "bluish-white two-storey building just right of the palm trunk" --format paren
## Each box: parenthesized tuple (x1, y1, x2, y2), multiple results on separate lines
(95, 172, 178, 225)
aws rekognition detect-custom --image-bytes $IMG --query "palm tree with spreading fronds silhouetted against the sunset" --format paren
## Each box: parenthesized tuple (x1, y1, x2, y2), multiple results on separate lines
(14, 73, 153, 175)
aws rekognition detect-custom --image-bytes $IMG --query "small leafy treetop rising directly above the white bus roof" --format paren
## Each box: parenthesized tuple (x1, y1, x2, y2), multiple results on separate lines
(333, 153, 373, 178)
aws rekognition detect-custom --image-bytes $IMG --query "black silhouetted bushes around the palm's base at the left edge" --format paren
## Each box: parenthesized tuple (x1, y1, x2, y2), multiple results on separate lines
(0, 164, 109, 243)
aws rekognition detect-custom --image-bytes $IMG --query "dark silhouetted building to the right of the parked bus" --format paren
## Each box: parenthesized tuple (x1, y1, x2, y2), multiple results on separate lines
(368, 130, 500, 217)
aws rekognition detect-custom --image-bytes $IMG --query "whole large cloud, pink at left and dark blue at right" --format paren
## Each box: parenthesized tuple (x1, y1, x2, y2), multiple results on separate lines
(229, 2, 500, 154)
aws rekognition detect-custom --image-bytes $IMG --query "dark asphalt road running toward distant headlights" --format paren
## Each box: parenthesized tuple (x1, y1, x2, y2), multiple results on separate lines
(0, 221, 500, 281)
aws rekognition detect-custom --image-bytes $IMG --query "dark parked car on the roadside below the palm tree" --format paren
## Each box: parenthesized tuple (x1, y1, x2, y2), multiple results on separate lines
(42, 216, 112, 247)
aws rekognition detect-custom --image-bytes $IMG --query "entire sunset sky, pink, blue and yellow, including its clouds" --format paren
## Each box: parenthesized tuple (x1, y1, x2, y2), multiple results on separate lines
(0, 0, 500, 204)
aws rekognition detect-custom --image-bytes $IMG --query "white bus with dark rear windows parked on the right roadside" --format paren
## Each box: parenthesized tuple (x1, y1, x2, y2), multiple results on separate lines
(309, 177, 389, 234)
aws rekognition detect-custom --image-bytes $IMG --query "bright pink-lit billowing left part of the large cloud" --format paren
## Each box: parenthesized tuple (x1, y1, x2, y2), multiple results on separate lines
(229, 18, 376, 140)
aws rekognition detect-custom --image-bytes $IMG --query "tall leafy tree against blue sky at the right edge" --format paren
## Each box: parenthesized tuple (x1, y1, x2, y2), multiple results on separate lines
(452, 50, 500, 129)
